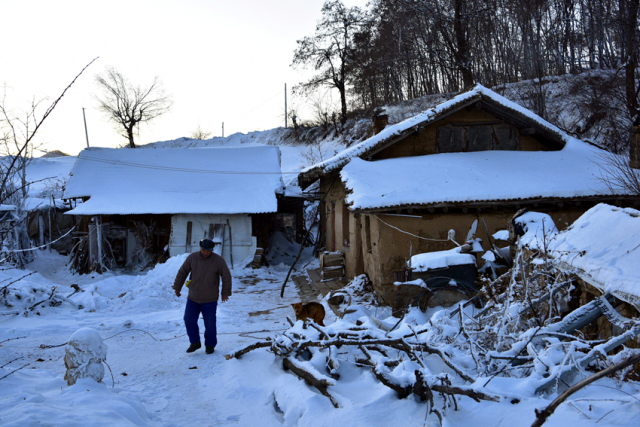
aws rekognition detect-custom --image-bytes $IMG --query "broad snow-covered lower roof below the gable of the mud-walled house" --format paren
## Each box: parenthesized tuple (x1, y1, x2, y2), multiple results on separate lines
(341, 138, 624, 210)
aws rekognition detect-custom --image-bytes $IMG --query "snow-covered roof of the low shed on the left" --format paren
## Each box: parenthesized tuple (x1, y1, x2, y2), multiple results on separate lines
(64, 146, 283, 215)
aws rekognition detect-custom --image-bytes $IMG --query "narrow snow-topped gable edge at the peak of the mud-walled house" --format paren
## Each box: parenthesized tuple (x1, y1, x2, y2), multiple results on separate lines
(301, 84, 570, 184)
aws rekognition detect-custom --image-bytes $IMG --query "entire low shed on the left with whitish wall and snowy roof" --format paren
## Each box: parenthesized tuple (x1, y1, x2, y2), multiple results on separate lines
(64, 146, 284, 272)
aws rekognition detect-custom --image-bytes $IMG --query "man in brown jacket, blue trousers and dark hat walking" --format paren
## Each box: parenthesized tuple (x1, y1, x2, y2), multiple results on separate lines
(173, 239, 231, 354)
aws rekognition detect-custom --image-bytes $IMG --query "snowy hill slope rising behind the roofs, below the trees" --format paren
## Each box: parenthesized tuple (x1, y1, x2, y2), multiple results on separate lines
(141, 70, 631, 175)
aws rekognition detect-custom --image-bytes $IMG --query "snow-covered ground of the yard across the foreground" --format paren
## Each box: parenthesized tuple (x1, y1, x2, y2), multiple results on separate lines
(0, 248, 640, 427)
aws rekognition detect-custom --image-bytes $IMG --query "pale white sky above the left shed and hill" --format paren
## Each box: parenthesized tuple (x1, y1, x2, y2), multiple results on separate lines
(0, 0, 367, 155)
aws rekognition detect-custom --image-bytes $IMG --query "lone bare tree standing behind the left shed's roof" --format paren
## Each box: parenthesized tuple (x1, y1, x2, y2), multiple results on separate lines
(95, 67, 172, 148)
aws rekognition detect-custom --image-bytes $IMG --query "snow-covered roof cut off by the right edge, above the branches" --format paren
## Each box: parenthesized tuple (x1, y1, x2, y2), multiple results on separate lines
(549, 203, 640, 304)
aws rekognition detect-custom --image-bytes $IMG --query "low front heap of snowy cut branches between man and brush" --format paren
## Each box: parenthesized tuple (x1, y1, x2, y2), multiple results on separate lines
(225, 320, 501, 419)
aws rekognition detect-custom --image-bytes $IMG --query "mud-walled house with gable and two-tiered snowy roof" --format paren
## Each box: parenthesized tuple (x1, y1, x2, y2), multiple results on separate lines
(299, 85, 633, 295)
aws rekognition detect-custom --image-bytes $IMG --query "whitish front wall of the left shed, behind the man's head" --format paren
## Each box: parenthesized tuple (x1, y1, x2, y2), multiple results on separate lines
(169, 214, 256, 267)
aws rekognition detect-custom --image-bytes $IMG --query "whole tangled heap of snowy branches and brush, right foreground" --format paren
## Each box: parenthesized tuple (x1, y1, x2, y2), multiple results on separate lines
(225, 244, 640, 422)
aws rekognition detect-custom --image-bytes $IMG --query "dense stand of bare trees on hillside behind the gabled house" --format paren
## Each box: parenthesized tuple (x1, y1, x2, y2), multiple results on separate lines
(289, 0, 639, 151)
